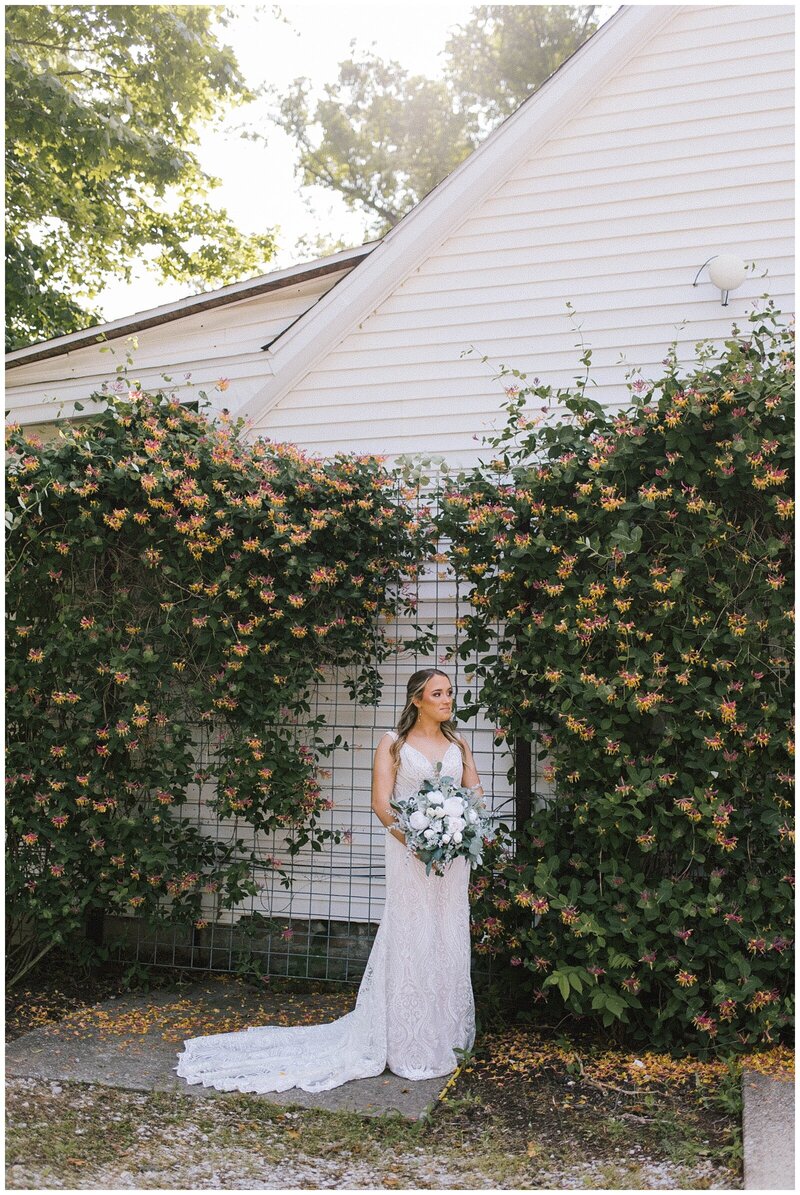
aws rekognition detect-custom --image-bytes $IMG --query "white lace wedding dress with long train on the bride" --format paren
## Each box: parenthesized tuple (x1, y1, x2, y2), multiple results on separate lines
(173, 730, 475, 1092)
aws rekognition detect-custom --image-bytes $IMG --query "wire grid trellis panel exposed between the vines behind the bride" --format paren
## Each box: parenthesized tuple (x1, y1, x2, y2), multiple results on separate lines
(109, 485, 541, 983)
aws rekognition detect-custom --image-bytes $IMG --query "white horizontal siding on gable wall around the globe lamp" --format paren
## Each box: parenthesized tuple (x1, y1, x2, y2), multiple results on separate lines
(255, 6, 794, 464)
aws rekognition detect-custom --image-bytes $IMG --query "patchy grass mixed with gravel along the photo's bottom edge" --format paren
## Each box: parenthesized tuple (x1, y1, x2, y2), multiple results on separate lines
(6, 1080, 740, 1189)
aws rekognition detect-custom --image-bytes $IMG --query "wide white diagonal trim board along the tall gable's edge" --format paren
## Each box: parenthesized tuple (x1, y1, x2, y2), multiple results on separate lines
(233, 5, 680, 421)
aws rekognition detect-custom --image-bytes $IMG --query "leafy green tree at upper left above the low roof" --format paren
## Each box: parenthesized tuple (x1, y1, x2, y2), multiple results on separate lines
(5, 5, 274, 348)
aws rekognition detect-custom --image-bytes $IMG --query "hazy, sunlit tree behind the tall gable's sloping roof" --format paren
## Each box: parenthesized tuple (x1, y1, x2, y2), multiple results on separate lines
(271, 5, 596, 237)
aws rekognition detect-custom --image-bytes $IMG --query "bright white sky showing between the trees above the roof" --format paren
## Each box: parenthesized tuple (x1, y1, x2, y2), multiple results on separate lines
(96, 0, 616, 320)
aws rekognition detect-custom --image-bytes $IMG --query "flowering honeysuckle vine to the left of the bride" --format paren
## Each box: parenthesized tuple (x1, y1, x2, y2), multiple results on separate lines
(6, 380, 430, 974)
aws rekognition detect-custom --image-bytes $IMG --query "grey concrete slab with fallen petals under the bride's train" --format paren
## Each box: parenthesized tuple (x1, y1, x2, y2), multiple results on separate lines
(6, 980, 447, 1120)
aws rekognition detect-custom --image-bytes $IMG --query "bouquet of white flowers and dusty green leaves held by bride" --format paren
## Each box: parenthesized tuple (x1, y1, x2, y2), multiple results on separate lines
(390, 764, 489, 876)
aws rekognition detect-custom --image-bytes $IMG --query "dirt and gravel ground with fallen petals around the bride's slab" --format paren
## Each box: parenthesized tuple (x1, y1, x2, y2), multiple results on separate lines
(6, 968, 741, 1190)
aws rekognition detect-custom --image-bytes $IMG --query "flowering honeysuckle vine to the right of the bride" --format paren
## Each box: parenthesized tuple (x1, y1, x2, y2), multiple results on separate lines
(440, 304, 794, 1053)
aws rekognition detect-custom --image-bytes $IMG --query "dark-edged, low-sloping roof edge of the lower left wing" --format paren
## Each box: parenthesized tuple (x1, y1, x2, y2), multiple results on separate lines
(6, 241, 378, 369)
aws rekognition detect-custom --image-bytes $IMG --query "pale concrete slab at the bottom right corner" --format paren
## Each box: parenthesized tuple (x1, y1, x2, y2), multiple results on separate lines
(741, 1068, 794, 1191)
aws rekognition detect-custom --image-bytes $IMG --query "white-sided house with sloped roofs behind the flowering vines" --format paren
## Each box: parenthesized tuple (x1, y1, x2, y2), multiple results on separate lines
(6, 5, 794, 960)
